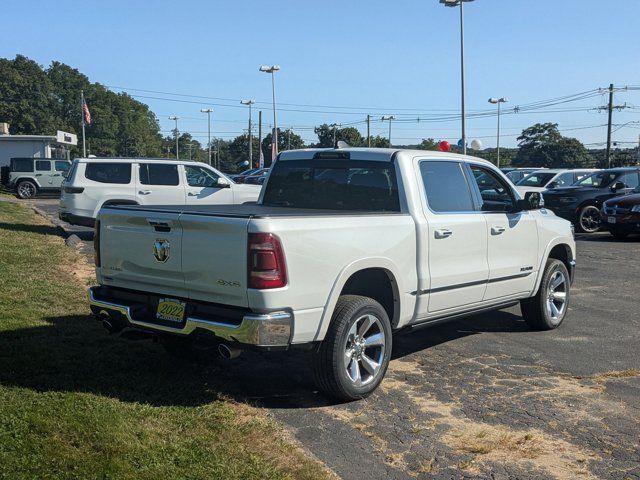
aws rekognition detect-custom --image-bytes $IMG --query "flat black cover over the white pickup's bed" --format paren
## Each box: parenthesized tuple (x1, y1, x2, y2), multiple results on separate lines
(109, 203, 405, 218)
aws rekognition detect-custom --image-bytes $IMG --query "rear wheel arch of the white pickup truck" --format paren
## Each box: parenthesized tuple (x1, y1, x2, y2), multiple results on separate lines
(315, 258, 403, 340)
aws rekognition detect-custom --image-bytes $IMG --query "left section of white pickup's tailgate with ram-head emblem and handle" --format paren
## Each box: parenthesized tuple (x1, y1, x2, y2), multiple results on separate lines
(100, 208, 188, 297)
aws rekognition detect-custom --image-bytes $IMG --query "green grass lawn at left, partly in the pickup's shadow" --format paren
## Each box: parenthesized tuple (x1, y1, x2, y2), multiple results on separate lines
(0, 201, 327, 480)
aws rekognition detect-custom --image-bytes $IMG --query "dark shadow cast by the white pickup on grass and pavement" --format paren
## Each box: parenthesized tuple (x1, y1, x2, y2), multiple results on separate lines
(0, 311, 528, 409)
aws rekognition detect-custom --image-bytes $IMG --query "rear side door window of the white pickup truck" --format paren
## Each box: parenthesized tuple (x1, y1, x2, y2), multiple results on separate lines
(420, 161, 474, 213)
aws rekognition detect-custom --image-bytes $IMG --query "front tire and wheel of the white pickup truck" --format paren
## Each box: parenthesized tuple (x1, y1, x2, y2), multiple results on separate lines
(520, 258, 570, 330)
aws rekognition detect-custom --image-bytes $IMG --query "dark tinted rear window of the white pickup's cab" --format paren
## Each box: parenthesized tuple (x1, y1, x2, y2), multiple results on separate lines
(262, 159, 400, 212)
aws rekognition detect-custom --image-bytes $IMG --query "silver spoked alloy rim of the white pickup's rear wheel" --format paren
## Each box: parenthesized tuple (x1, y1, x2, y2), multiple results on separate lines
(344, 314, 386, 387)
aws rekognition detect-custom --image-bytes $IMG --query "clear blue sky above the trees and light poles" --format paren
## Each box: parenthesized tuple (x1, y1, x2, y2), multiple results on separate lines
(0, 0, 640, 146)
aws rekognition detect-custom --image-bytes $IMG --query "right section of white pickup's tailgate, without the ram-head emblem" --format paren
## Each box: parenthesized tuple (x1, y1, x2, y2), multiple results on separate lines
(180, 212, 249, 307)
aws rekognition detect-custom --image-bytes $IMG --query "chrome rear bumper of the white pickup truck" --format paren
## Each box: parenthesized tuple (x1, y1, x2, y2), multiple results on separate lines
(88, 287, 293, 347)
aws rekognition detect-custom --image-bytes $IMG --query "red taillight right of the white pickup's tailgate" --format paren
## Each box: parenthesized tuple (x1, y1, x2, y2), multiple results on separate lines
(247, 233, 287, 290)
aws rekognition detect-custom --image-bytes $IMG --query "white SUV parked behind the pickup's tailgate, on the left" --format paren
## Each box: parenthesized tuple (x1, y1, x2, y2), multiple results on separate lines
(58, 158, 261, 227)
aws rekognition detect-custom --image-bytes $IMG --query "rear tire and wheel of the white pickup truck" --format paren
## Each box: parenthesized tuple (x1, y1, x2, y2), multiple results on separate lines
(313, 295, 392, 400)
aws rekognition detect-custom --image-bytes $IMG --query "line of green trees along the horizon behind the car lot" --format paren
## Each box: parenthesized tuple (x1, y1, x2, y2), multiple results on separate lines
(0, 55, 637, 172)
